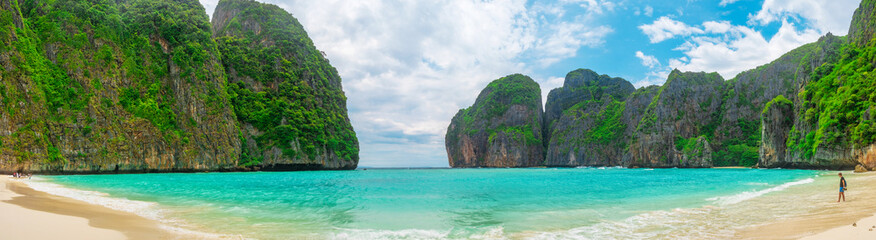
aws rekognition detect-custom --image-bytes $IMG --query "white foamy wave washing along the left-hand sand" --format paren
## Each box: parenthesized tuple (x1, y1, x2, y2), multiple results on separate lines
(22, 177, 231, 239)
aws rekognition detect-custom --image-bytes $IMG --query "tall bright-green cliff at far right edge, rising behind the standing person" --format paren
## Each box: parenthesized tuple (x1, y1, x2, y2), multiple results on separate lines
(761, 0, 876, 169)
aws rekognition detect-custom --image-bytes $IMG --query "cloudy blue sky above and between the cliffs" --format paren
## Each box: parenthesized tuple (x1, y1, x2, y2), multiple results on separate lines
(200, 0, 860, 167)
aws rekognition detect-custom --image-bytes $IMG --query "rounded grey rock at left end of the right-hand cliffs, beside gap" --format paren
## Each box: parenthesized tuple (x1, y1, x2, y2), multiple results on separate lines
(445, 74, 544, 167)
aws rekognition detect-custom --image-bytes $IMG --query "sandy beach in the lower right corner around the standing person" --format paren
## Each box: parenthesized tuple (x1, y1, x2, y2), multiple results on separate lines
(737, 171, 876, 240)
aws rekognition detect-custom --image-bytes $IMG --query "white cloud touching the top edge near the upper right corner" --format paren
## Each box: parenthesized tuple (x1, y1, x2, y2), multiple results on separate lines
(749, 0, 861, 35)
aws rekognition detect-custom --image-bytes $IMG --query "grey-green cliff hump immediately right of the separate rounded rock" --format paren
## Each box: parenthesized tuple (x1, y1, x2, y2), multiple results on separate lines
(544, 69, 636, 166)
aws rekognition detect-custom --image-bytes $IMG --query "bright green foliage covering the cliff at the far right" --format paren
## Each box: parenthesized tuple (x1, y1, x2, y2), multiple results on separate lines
(790, 37, 876, 158)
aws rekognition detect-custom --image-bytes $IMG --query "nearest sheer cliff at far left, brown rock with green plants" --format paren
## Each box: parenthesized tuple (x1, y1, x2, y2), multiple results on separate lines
(0, 0, 356, 173)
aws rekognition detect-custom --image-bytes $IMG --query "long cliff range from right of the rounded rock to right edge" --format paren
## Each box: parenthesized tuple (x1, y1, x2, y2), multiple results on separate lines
(446, 0, 876, 170)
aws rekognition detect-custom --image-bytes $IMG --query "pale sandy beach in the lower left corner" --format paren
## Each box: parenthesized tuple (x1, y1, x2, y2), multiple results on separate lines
(0, 176, 179, 239)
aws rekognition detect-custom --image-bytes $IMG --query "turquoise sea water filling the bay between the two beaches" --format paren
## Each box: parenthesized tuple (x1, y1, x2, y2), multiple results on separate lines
(38, 168, 820, 239)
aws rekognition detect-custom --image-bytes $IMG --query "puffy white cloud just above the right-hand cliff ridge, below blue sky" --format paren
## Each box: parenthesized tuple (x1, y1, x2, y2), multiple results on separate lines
(669, 21, 821, 79)
